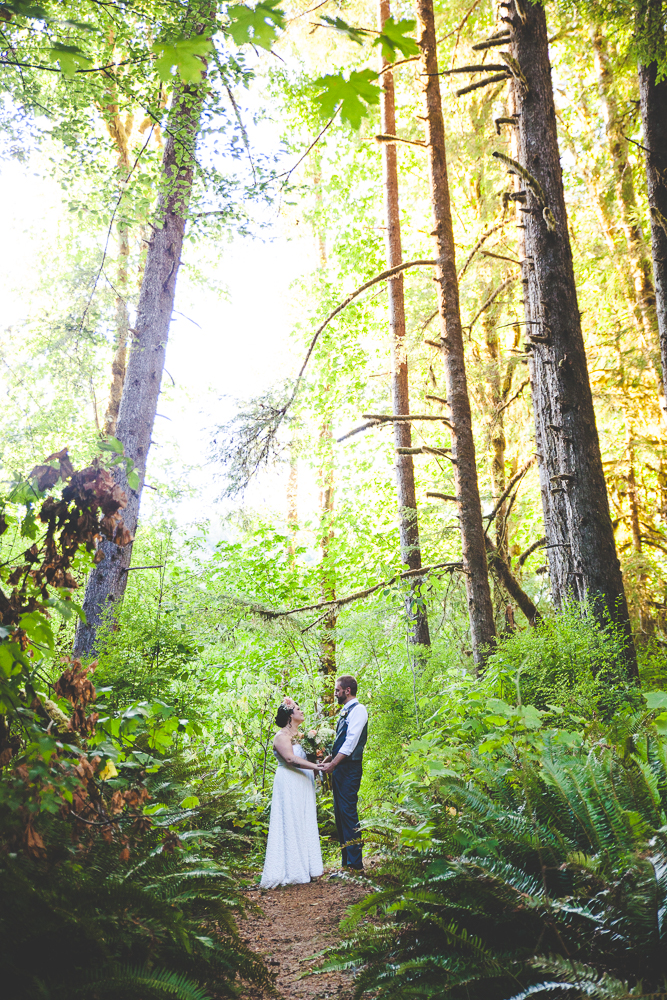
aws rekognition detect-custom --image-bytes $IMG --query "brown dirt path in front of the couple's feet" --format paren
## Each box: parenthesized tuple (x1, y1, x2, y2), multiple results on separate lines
(239, 874, 368, 1000)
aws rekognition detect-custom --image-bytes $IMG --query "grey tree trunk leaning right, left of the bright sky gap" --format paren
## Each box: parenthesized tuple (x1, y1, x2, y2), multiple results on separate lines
(74, 85, 204, 656)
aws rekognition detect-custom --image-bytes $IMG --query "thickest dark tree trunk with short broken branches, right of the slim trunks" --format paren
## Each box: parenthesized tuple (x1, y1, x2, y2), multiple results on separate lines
(503, 3, 637, 675)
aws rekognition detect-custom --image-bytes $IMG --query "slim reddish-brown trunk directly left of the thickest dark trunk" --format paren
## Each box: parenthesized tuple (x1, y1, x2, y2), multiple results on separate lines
(417, 0, 496, 666)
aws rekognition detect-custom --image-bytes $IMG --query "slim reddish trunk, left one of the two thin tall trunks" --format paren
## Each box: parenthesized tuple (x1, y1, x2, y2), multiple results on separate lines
(378, 0, 431, 646)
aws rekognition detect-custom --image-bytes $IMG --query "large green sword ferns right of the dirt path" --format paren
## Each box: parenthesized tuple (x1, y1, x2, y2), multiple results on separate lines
(331, 729, 667, 1000)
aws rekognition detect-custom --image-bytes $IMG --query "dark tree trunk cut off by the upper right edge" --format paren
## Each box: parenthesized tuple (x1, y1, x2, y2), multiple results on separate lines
(636, 0, 667, 410)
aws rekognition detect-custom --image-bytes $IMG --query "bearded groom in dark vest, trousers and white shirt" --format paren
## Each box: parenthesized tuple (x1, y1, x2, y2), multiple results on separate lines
(322, 675, 368, 871)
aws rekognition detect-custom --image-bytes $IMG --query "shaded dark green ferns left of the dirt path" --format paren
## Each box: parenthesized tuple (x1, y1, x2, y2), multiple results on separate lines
(0, 758, 267, 1000)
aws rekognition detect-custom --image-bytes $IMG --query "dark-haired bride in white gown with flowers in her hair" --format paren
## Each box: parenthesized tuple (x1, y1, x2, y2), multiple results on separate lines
(259, 698, 324, 889)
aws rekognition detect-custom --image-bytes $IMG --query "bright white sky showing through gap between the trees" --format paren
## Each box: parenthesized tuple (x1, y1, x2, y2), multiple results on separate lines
(0, 131, 322, 536)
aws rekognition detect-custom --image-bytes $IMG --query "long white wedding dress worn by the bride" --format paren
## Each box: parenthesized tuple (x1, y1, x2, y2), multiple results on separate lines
(259, 743, 324, 889)
